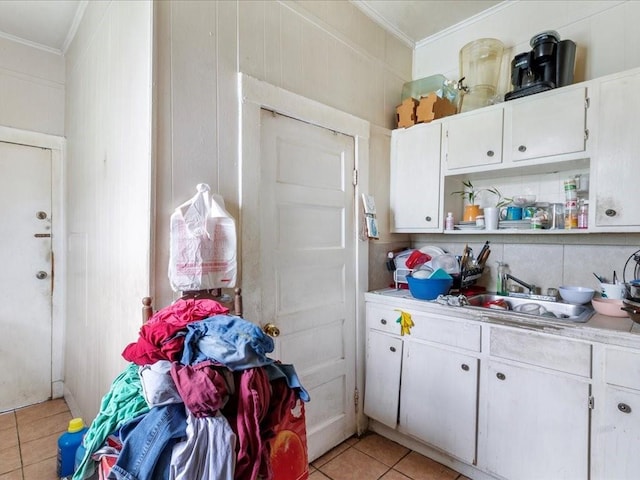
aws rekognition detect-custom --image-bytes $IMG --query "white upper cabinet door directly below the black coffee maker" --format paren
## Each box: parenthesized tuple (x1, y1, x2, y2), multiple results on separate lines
(510, 88, 586, 161)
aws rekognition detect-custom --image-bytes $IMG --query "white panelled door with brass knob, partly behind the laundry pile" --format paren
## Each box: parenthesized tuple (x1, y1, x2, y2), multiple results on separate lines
(258, 110, 357, 460)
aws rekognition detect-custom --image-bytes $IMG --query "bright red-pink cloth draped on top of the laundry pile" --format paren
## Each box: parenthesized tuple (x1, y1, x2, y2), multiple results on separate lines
(122, 298, 229, 365)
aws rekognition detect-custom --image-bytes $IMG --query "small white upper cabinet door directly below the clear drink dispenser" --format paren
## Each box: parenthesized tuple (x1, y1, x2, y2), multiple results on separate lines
(443, 108, 503, 170)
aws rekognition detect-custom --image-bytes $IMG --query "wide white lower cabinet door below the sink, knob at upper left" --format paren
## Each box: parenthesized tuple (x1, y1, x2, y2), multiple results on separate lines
(478, 360, 590, 480)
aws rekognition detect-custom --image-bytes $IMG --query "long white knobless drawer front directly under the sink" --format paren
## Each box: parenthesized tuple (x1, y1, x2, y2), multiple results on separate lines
(489, 328, 591, 378)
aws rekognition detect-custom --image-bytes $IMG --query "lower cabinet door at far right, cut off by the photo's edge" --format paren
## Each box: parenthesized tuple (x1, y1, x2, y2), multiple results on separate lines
(593, 385, 640, 480)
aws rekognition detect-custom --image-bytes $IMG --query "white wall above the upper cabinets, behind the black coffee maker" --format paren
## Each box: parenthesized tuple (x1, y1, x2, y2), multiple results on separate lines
(413, 0, 640, 100)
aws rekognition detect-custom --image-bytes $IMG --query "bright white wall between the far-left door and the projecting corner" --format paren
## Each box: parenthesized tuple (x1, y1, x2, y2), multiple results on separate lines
(65, 1, 152, 420)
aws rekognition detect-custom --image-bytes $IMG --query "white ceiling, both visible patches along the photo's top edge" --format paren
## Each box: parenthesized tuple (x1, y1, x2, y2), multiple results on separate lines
(0, 0, 502, 53)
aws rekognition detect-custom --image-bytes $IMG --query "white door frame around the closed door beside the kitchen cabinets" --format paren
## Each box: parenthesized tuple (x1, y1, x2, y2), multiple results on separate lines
(238, 73, 370, 434)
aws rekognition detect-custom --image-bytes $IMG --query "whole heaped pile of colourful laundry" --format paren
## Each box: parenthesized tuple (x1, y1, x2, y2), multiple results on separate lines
(73, 298, 309, 480)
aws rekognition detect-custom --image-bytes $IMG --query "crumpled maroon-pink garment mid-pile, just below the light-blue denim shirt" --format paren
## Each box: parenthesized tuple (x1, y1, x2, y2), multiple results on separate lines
(171, 360, 233, 418)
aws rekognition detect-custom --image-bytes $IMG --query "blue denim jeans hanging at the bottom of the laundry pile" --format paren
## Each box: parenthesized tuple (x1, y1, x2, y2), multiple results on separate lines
(108, 403, 187, 480)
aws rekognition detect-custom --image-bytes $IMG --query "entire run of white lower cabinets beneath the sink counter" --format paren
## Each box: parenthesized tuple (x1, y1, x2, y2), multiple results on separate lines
(364, 294, 640, 480)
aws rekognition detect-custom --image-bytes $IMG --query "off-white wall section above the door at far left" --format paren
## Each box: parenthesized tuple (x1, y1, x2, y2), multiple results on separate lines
(0, 37, 65, 135)
